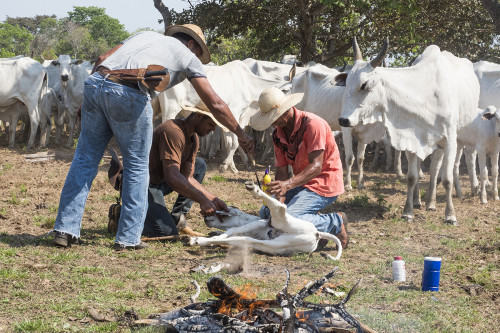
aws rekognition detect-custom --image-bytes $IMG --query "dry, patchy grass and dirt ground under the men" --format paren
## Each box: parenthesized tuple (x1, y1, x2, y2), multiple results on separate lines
(0, 134, 500, 332)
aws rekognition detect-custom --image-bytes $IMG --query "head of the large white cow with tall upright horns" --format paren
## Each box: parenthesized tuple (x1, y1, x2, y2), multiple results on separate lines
(335, 37, 389, 127)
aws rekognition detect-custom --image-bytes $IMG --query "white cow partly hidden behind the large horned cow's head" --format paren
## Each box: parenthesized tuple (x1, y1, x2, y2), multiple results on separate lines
(291, 64, 391, 190)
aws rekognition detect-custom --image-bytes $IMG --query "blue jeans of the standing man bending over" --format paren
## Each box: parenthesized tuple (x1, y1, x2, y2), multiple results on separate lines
(54, 73, 153, 246)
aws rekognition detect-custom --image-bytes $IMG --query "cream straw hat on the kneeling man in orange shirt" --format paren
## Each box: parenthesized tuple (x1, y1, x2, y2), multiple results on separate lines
(250, 87, 304, 131)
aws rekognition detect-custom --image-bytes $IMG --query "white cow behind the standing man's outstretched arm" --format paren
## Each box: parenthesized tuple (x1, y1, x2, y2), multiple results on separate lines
(158, 60, 282, 173)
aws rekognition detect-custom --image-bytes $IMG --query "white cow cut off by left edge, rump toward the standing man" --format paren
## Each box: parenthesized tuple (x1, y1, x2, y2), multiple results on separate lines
(0, 56, 49, 148)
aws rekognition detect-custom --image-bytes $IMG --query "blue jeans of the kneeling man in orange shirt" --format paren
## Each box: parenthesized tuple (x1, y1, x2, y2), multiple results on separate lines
(259, 187, 342, 235)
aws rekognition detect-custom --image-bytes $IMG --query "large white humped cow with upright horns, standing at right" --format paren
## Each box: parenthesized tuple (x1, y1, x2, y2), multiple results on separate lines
(337, 39, 479, 224)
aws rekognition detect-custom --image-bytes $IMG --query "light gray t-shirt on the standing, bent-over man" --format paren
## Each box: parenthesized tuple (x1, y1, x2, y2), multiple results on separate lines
(101, 31, 207, 89)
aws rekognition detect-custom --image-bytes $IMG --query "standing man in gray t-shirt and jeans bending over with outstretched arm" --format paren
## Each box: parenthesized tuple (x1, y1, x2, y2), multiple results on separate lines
(53, 24, 254, 251)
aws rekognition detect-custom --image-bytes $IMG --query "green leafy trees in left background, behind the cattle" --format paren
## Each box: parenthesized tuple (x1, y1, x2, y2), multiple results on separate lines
(0, 6, 129, 60)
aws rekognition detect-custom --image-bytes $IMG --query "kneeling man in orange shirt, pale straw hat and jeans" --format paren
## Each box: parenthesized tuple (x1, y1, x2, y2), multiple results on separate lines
(250, 87, 349, 249)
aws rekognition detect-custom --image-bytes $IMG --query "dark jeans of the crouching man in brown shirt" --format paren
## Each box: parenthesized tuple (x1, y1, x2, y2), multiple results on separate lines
(142, 157, 207, 237)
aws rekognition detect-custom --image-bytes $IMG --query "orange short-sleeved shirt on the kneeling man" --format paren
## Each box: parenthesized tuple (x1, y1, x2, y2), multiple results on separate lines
(274, 108, 344, 197)
